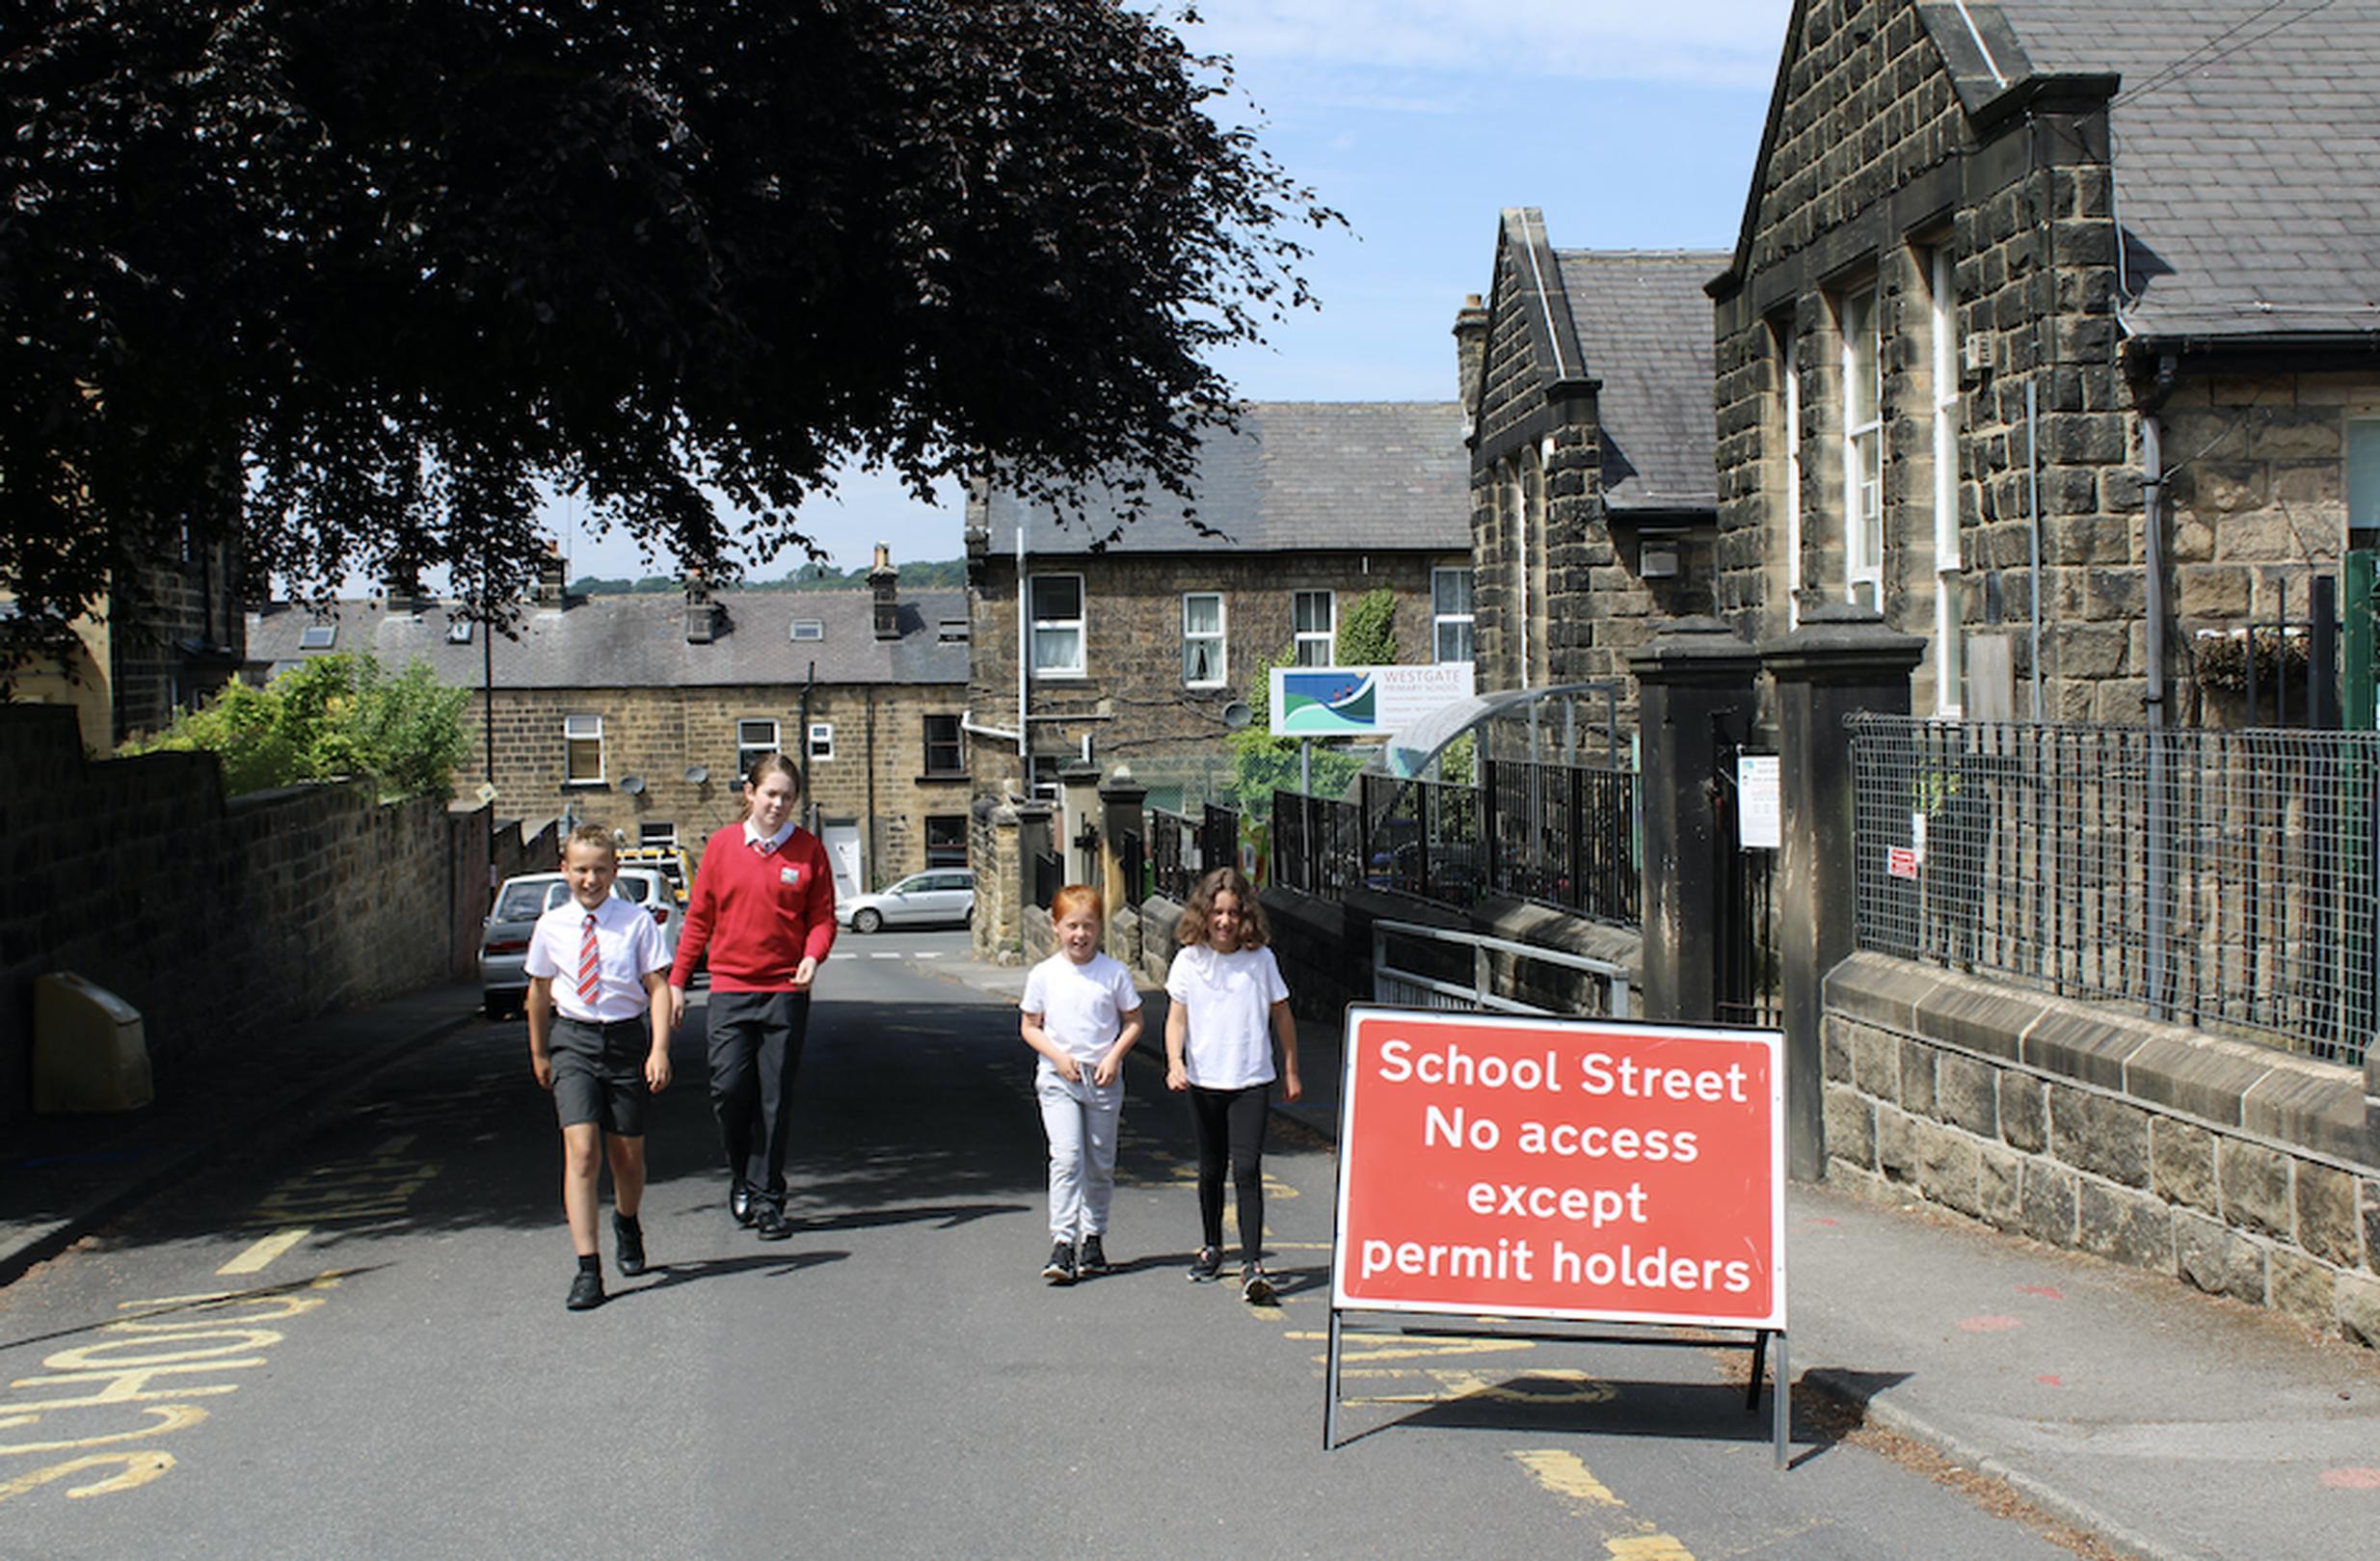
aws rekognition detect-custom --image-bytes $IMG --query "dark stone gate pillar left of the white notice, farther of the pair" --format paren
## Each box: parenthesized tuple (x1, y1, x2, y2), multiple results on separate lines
(1628, 616, 1761, 1021)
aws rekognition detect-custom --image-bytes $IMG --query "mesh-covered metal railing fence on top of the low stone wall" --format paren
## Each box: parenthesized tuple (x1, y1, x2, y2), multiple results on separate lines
(1852, 716, 2380, 1063)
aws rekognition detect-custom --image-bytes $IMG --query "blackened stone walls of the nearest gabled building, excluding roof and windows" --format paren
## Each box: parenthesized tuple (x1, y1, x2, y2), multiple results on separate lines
(1716, 0, 2380, 723)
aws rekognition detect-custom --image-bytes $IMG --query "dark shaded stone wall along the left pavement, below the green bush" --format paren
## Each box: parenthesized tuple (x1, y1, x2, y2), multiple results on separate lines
(0, 707, 486, 1123)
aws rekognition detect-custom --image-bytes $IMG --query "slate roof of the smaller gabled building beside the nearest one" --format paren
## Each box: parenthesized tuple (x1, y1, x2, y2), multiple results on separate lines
(1554, 250, 1727, 509)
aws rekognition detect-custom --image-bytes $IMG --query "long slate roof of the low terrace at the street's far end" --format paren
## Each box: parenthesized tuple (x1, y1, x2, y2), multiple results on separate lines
(248, 590, 966, 687)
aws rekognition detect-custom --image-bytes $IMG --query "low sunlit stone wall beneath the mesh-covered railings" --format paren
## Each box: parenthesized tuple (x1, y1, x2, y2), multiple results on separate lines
(1826, 955, 2380, 1347)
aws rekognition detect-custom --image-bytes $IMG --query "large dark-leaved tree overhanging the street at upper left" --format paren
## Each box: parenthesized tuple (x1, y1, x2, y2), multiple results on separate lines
(0, 0, 1338, 619)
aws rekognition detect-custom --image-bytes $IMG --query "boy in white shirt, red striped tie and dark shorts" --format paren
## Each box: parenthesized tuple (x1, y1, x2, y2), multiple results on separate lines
(526, 823, 669, 1311)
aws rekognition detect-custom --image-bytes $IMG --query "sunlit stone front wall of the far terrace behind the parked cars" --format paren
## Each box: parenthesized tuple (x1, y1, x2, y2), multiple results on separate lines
(460, 683, 969, 888)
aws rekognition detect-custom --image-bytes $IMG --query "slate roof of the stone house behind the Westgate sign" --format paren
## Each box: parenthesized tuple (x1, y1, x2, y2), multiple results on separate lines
(983, 402, 1465, 557)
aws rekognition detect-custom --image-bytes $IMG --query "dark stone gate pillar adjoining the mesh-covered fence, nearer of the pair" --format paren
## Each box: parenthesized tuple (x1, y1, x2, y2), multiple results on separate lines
(1761, 602, 1925, 1180)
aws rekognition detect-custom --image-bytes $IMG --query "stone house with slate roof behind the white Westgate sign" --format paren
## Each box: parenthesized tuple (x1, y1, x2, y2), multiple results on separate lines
(966, 402, 1471, 809)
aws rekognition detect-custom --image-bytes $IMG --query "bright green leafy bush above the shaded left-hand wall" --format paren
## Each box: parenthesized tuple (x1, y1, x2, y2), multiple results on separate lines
(123, 655, 471, 802)
